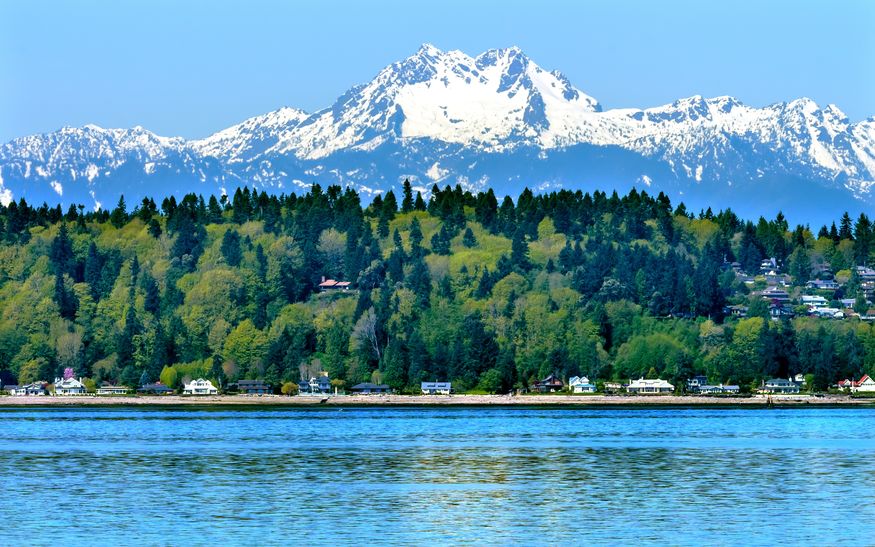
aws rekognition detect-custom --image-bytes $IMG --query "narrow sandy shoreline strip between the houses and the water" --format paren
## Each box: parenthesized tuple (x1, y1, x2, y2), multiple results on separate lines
(0, 395, 875, 408)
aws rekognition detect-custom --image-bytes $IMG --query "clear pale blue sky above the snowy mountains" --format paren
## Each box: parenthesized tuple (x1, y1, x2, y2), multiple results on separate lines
(0, 0, 875, 142)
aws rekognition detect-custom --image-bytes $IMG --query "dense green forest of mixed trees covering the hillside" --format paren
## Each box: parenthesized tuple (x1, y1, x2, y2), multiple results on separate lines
(0, 183, 875, 393)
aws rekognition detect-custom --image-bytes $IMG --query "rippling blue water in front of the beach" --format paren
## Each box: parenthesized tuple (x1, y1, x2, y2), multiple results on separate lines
(0, 407, 875, 545)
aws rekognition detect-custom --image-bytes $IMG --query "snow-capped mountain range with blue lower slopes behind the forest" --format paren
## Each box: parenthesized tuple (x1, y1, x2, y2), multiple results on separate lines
(0, 44, 875, 225)
